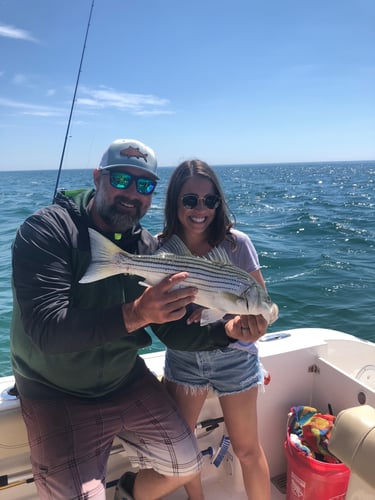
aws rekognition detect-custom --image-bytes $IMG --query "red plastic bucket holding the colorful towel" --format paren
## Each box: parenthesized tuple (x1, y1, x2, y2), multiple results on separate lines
(284, 434, 350, 500)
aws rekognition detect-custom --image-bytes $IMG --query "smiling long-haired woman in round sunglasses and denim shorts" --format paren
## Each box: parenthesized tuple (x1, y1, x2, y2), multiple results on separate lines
(159, 160, 270, 500)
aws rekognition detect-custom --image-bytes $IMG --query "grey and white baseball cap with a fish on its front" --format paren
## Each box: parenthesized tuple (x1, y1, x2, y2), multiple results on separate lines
(99, 139, 159, 180)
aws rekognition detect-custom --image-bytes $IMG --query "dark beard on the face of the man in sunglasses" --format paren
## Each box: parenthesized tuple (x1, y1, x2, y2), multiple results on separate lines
(97, 196, 146, 233)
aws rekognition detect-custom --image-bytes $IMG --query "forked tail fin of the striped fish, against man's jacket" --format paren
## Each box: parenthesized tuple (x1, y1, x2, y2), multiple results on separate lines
(79, 228, 126, 283)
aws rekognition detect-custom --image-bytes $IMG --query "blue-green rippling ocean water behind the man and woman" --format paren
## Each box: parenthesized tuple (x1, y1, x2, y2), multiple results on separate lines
(0, 161, 375, 376)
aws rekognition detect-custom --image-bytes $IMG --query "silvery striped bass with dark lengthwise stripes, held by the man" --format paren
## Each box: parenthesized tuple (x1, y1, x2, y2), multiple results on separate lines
(79, 228, 278, 323)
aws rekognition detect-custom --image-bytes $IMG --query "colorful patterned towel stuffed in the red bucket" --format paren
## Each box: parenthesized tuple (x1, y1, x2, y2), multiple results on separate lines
(288, 405, 340, 463)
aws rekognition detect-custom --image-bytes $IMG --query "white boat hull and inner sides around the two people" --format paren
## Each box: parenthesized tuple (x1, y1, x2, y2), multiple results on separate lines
(0, 328, 375, 500)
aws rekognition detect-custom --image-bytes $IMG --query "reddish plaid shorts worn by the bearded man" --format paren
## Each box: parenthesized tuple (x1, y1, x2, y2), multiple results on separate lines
(21, 361, 201, 500)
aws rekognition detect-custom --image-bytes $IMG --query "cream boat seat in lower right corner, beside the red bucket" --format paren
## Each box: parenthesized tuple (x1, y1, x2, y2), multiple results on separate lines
(328, 405, 375, 498)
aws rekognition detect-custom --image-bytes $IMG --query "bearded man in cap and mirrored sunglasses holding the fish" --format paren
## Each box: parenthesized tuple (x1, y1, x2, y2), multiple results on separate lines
(11, 139, 260, 500)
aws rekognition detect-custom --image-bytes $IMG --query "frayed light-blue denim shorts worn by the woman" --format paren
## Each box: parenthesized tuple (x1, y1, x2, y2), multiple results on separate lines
(164, 347, 264, 396)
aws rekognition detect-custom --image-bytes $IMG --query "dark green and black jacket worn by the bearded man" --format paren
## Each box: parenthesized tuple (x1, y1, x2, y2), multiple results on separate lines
(11, 190, 230, 398)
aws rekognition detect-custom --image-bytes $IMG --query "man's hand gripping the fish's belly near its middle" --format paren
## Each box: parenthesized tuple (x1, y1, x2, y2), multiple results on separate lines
(122, 273, 198, 332)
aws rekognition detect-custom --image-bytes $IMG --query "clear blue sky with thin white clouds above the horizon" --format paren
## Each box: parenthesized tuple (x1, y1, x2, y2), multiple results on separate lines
(0, 0, 375, 170)
